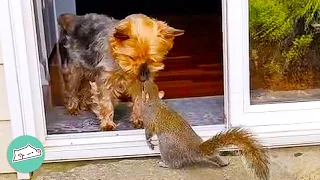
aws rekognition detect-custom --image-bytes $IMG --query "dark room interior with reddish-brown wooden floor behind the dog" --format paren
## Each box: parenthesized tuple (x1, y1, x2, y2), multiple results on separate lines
(50, 15, 223, 105)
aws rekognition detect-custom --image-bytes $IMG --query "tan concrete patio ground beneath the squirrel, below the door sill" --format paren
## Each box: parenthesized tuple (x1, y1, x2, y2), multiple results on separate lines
(0, 146, 320, 180)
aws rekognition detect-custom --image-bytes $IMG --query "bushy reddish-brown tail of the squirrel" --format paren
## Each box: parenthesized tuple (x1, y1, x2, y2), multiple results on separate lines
(200, 127, 269, 180)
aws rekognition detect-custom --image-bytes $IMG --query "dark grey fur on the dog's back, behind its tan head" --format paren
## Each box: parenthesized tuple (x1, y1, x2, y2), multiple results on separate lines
(64, 13, 119, 71)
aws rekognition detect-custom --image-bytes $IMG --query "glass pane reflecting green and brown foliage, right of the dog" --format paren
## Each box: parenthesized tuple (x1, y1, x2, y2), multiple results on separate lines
(249, 0, 320, 104)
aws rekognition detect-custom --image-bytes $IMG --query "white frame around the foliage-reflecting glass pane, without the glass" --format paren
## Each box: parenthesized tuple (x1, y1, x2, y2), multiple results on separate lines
(227, 0, 320, 146)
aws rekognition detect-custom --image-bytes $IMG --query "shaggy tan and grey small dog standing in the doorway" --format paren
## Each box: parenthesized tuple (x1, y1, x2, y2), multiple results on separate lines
(58, 14, 184, 130)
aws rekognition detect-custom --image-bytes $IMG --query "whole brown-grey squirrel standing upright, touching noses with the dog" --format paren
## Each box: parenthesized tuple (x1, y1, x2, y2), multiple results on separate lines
(135, 81, 269, 180)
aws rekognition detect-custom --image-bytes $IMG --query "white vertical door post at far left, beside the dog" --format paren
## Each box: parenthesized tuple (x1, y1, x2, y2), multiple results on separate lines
(0, 0, 45, 179)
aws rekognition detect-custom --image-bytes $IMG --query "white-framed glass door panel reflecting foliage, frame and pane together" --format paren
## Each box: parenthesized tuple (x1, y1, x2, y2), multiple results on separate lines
(227, 0, 320, 137)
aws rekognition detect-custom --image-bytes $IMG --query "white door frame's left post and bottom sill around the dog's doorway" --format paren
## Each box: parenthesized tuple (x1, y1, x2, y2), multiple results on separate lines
(0, 0, 225, 166)
